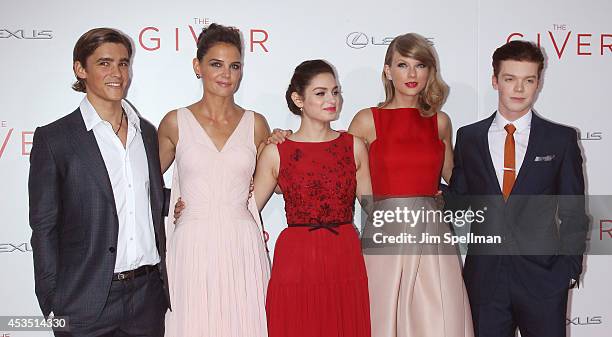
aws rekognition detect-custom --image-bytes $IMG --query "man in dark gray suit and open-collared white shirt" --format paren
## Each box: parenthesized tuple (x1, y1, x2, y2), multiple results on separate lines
(28, 28, 169, 336)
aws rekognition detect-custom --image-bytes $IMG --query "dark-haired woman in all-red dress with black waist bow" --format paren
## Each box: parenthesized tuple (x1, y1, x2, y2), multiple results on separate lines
(254, 60, 371, 337)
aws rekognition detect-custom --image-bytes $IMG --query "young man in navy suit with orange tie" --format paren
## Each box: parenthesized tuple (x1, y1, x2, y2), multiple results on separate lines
(449, 41, 588, 337)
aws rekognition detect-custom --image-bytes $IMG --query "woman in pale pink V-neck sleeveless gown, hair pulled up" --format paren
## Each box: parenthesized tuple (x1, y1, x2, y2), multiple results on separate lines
(159, 24, 270, 337)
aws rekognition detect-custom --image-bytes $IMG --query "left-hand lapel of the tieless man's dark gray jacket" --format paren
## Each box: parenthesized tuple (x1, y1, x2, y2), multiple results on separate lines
(69, 109, 115, 202)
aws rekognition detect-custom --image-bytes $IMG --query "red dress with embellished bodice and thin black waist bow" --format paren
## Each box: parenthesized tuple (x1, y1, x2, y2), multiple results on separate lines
(266, 133, 370, 337)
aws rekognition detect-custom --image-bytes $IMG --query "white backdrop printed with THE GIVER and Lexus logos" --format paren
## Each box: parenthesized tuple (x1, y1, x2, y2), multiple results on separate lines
(0, 0, 612, 337)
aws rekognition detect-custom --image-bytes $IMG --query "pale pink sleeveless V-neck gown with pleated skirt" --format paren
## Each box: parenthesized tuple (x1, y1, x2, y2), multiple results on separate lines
(166, 108, 270, 337)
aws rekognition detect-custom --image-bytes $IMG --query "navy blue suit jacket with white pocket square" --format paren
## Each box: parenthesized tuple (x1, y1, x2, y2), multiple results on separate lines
(447, 113, 588, 303)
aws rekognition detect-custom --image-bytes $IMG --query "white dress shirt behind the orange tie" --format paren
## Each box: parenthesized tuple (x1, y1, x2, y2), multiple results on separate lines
(488, 111, 533, 189)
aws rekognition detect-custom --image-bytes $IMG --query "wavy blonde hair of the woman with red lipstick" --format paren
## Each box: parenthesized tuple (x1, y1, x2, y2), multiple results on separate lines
(378, 33, 448, 115)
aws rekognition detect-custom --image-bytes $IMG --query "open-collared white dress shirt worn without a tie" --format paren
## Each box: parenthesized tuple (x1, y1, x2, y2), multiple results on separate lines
(80, 97, 160, 273)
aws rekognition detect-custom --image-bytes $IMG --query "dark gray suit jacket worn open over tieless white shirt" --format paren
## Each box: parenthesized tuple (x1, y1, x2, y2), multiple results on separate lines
(28, 109, 170, 322)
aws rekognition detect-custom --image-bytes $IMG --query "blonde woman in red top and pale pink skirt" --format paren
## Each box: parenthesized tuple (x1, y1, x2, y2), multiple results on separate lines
(349, 33, 473, 337)
